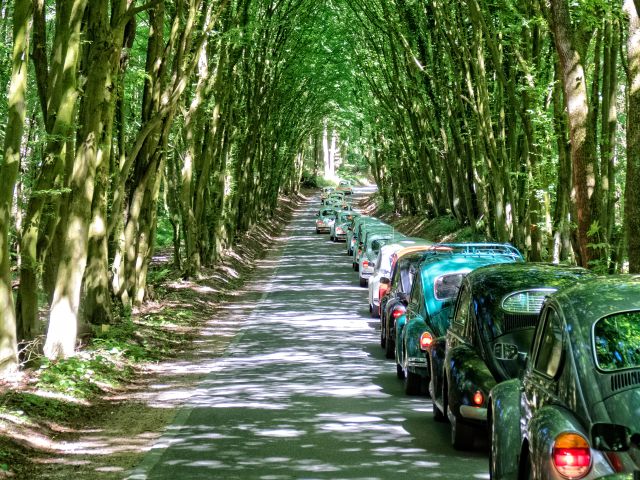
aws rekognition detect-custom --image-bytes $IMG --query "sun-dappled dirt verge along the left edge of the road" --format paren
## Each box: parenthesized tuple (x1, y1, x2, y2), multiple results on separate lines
(0, 189, 307, 480)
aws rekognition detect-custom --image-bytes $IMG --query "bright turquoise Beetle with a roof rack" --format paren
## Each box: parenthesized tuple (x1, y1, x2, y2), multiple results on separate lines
(395, 243, 524, 395)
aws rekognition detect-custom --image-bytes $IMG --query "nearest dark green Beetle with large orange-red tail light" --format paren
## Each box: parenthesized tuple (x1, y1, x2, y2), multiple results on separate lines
(487, 275, 640, 480)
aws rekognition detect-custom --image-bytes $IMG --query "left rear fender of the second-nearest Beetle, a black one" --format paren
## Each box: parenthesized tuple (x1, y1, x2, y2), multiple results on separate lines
(444, 344, 496, 421)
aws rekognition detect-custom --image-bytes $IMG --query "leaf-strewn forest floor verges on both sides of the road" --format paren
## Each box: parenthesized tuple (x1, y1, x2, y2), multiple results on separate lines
(0, 186, 476, 480)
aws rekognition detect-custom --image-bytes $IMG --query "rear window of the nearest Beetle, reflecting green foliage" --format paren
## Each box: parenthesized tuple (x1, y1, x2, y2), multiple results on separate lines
(593, 311, 640, 371)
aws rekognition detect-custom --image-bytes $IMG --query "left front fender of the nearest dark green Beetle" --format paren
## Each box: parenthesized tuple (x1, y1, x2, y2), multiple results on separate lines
(487, 379, 522, 480)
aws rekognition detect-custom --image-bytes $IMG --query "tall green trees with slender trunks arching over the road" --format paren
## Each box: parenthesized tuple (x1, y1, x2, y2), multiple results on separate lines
(0, 0, 640, 370)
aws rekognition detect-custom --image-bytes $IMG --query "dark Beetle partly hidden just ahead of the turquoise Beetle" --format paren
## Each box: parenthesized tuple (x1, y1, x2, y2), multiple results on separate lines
(380, 246, 436, 359)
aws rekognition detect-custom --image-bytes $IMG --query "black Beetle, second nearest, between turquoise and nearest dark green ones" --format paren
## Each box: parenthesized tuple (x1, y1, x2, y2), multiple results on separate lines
(440, 263, 595, 449)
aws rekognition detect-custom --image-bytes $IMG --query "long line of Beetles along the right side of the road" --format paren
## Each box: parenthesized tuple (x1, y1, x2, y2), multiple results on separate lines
(316, 187, 640, 479)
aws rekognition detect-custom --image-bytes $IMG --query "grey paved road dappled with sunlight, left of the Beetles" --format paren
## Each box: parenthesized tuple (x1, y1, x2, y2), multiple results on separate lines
(128, 191, 489, 480)
